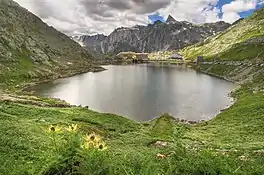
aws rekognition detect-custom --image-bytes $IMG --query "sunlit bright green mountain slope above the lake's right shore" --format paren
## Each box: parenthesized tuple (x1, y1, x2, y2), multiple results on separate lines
(180, 8, 264, 62)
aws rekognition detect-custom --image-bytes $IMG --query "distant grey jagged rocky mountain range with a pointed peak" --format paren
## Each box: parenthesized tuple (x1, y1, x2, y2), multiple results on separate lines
(73, 16, 230, 54)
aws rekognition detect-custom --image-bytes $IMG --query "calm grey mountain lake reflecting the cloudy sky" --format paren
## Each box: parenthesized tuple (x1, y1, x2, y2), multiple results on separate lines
(30, 64, 237, 121)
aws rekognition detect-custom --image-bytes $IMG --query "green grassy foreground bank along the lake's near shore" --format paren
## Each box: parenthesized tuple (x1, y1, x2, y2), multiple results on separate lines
(0, 62, 264, 175)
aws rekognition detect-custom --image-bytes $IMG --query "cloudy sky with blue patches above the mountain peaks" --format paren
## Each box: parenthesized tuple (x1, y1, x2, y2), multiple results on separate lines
(14, 0, 264, 36)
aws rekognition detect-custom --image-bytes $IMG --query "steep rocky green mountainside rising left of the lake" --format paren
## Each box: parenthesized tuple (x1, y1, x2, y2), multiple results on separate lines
(0, 0, 99, 85)
